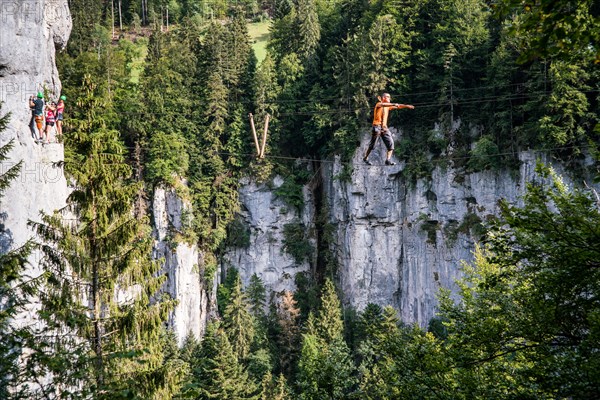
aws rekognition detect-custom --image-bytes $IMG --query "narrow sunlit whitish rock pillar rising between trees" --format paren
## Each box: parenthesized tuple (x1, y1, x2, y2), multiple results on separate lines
(152, 187, 215, 345)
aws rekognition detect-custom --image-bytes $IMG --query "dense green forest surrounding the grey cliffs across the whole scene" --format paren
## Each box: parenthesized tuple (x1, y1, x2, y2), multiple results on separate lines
(0, 0, 600, 400)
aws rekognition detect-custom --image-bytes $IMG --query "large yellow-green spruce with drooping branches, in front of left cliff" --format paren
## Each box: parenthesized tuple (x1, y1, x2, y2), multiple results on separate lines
(32, 76, 174, 398)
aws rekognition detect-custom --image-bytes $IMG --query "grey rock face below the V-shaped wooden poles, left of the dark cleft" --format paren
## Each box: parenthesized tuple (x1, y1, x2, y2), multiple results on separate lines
(222, 177, 314, 293)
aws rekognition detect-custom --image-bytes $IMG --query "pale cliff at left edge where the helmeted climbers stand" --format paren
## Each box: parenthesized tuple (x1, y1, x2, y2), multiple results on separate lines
(0, 0, 72, 288)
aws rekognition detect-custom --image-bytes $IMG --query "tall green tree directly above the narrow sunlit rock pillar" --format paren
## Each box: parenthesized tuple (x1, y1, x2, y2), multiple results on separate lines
(139, 28, 198, 186)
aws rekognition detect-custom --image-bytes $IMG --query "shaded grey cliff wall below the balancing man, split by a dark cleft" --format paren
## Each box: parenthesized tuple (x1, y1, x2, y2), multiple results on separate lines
(227, 134, 576, 327)
